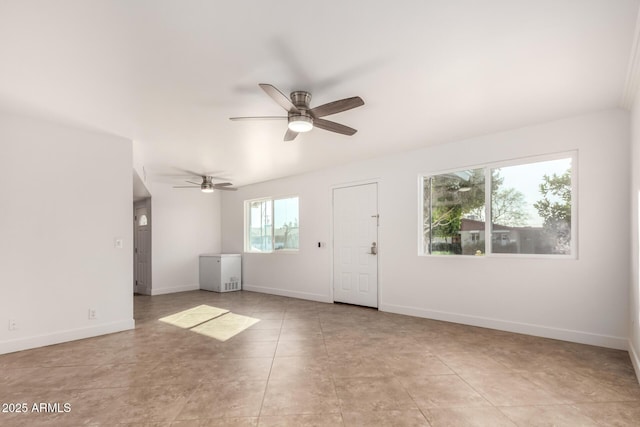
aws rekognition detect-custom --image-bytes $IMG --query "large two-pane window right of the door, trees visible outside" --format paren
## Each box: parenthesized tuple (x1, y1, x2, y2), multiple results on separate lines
(421, 154, 575, 256)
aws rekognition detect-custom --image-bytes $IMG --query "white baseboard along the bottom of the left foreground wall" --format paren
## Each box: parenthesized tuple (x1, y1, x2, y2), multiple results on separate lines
(0, 319, 135, 354)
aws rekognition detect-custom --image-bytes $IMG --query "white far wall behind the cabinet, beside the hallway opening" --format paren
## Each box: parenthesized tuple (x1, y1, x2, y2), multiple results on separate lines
(150, 182, 220, 295)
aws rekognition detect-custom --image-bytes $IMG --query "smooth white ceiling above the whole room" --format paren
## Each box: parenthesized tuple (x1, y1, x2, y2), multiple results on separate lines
(0, 0, 639, 185)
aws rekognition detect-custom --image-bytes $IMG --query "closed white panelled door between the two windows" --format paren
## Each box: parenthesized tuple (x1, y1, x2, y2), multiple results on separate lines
(333, 184, 378, 307)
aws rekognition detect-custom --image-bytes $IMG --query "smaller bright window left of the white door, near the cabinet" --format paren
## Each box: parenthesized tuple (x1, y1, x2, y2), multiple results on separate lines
(245, 197, 299, 252)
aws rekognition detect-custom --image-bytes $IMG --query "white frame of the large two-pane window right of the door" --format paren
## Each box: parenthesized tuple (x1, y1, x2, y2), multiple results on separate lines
(418, 150, 578, 260)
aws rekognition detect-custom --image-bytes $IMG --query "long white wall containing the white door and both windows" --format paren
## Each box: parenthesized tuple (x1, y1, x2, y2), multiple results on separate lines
(222, 110, 630, 349)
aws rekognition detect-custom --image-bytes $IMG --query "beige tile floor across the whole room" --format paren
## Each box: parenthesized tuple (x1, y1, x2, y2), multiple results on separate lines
(0, 291, 640, 426)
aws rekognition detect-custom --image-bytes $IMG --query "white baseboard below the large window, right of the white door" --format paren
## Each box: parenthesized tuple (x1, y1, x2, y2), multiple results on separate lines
(379, 304, 628, 350)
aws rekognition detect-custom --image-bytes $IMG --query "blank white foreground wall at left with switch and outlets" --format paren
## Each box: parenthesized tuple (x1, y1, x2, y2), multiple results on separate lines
(0, 112, 134, 353)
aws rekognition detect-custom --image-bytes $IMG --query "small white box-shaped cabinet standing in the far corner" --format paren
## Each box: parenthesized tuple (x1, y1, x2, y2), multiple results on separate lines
(200, 254, 242, 292)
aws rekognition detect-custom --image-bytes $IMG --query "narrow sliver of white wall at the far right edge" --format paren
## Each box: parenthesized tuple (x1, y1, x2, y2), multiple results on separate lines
(629, 99, 640, 379)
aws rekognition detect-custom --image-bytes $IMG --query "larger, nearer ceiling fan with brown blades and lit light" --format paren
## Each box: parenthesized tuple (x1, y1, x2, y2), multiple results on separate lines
(230, 83, 364, 141)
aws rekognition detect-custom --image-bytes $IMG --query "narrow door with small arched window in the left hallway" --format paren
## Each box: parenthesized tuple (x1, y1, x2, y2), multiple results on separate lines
(133, 203, 151, 294)
